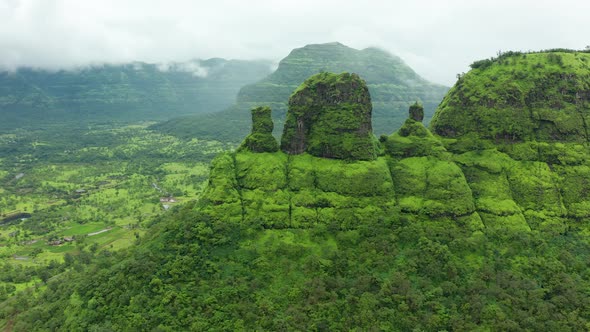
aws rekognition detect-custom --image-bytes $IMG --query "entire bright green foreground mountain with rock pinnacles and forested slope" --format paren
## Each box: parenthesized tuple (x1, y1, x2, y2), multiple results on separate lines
(5, 52, 590, 331)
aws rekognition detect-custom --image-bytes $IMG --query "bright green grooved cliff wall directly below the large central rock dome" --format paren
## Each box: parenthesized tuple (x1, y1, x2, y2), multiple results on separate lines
(202, 151, 396, 229)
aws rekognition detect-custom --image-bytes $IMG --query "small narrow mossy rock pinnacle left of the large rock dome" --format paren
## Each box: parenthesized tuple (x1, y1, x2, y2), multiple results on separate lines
(240, 106, 279, 152)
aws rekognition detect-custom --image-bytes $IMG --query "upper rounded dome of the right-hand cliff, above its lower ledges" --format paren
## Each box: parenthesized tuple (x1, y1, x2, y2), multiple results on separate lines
(431, 52, 590, 143)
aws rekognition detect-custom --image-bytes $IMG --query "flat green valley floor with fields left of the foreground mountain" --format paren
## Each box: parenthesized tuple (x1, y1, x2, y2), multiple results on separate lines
(0, 123, 228, 300)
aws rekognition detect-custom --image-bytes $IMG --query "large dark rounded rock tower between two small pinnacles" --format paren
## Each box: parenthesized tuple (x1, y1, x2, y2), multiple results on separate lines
(281, 73, 375, 160)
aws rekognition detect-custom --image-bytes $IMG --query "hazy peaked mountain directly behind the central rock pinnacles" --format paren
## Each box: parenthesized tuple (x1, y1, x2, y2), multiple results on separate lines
(153, 43, 448, 142)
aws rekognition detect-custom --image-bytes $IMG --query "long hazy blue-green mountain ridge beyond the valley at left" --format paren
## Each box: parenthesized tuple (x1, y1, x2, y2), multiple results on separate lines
(0, 58, 271, 128)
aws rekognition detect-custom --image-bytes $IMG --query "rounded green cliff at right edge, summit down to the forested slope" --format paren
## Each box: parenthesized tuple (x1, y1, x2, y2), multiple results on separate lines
(431, 50, 590, 232)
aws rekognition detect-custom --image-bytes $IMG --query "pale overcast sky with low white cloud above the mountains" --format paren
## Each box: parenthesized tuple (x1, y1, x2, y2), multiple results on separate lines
(0, 0, 590, 85)
